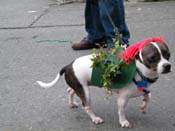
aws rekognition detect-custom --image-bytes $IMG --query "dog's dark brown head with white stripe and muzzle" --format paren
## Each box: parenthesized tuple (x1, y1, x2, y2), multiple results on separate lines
(136, 42, 171, 77)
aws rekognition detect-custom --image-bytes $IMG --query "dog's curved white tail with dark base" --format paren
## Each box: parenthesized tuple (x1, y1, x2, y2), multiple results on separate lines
(37, 66, 66, 88)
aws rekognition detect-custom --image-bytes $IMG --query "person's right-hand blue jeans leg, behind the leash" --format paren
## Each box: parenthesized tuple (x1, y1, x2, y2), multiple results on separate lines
(99, 0, 130, 47)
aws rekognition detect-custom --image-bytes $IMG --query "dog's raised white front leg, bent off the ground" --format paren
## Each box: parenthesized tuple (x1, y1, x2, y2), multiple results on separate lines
(140, 93, 151, 113)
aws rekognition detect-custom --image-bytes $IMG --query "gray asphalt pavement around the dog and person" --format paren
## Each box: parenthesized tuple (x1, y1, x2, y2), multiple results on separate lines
(0, 0, 175, 131)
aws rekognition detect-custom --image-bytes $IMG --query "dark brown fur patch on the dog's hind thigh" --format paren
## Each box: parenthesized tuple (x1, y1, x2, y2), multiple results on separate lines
(64, 62, 86, 106)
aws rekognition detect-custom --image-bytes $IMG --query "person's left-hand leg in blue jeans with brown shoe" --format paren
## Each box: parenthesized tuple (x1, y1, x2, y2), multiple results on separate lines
(72, 0, 106, 50)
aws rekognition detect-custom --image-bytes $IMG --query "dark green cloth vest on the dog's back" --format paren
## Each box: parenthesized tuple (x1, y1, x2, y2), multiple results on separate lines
(91, 55, 136, 89)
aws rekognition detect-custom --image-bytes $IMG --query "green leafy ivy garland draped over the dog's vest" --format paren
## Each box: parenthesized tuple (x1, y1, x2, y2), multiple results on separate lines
(91, 39, 126, 95)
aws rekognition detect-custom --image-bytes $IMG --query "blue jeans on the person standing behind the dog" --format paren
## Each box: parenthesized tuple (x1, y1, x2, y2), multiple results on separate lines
(85, 0, 130, 47)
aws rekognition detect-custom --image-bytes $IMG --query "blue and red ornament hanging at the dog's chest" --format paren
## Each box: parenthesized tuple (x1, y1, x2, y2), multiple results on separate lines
(133, 78, 150, 94)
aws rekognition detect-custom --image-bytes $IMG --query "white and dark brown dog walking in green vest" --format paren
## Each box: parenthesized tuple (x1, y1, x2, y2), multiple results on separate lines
(37, 36, 171, 128)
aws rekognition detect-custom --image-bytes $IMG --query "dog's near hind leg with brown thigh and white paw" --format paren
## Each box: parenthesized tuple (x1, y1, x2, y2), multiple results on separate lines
(65, 65, 103, 124)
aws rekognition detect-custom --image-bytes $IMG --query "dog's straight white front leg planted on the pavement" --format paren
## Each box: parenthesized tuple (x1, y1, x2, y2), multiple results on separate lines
(117, 95, 131, 128)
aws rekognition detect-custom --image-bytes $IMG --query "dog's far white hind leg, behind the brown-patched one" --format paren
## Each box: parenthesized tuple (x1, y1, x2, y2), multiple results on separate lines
(67, 87, 78, 108)
